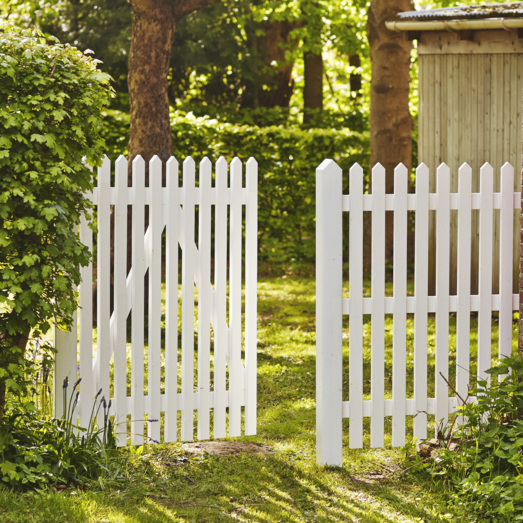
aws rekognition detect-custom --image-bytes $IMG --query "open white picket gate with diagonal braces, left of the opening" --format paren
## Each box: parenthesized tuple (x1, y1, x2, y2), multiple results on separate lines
(55, 156, 258, 445)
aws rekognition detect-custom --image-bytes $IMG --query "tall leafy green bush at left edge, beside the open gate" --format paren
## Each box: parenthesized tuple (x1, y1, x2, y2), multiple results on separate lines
(0, 23, 111, 406)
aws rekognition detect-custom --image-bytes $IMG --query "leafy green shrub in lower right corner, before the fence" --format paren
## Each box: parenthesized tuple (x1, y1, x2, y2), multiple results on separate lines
(408, 355, 523, 522)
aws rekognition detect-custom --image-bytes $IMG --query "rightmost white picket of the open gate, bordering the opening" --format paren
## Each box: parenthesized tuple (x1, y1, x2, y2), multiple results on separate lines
(245, 158, 258, 436)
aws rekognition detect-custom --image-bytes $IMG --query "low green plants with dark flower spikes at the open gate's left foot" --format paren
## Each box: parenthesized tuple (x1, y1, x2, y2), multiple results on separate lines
(0, 380, 125, 489)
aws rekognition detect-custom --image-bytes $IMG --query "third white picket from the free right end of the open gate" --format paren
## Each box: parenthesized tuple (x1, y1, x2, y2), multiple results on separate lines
(213, 156, 229, 439)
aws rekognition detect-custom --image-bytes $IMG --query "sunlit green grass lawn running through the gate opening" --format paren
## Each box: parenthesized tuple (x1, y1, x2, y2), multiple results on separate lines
(0, 277, 508, 523)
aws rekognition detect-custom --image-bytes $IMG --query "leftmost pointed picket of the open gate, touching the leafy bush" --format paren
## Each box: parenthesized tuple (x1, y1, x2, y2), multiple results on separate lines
(95, 157, 111, 426)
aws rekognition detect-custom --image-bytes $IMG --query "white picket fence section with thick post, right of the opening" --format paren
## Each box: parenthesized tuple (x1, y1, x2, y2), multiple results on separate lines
(316, 160, 521, 466)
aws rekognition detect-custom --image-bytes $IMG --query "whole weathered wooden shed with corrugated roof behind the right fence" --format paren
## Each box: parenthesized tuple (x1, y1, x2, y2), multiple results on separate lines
(387, 2, 523, 293)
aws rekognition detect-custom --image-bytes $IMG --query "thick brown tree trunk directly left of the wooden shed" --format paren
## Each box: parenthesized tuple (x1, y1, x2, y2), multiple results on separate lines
(364, 0, 414, 273)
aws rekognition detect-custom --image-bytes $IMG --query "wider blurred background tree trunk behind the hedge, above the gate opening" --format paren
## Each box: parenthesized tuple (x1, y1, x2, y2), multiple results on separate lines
(241, 20, 298, 108)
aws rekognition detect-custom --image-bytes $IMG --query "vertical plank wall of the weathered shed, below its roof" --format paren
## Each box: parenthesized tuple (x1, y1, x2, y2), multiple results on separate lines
(418, 31, 523, 294)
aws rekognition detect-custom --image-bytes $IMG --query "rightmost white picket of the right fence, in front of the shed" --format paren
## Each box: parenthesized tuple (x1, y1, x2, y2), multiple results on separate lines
(499, 162, 514, 359)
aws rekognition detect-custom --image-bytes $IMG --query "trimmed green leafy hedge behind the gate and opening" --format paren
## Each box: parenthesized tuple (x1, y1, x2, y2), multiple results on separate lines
(100, 111, 369, 266)
